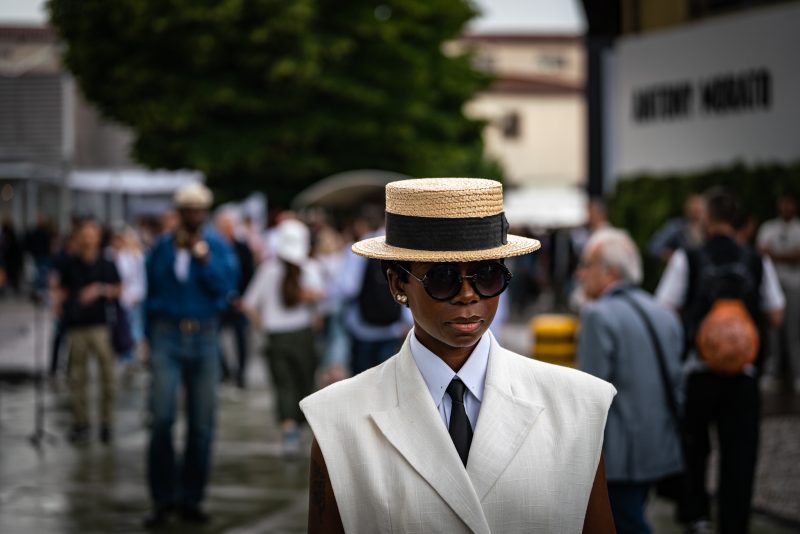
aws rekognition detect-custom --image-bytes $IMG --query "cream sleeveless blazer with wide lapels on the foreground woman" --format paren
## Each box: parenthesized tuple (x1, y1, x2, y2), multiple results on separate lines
(300, 334, 616, 534)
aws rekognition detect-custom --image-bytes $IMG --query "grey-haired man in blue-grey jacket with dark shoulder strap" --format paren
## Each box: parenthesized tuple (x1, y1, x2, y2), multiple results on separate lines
(578, 228, 683, 534)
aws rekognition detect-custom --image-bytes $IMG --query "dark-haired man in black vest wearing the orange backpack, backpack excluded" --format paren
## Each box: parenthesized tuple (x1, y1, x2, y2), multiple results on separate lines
(656, 189, 785, 534)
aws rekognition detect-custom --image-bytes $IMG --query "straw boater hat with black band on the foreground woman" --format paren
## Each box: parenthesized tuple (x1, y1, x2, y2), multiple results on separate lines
(353, 178, 541, 262)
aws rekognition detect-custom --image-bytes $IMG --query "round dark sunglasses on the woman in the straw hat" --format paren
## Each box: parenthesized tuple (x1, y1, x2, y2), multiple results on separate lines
(397, 261, 511, 300)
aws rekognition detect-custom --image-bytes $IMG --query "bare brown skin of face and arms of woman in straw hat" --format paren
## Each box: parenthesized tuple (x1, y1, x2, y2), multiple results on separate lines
(308, 263, 615, 534)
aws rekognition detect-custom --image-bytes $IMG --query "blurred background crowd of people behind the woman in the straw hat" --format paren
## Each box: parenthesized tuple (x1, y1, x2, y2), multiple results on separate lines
(0, 184, 800, 532)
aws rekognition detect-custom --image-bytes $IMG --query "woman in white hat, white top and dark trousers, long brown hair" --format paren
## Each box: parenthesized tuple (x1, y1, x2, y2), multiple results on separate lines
(243, 219, 324, 455)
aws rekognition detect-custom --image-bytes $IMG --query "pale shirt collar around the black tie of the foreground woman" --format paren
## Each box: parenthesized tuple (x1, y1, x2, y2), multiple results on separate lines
(410, 331, 491, 408)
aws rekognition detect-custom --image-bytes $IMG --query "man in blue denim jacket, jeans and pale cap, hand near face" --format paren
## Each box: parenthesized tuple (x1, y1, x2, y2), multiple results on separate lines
(145, 183, 239, 528)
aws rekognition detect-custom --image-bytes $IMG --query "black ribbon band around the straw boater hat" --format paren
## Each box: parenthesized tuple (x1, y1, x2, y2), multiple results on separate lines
(386, 212, 508, 252)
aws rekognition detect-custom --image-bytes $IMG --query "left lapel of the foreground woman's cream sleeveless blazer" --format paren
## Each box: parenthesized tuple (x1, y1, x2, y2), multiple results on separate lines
(371, 342, 490, 534)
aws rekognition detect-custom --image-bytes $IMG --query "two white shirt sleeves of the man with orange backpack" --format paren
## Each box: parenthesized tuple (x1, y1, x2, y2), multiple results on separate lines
(656, 249, 786, 312)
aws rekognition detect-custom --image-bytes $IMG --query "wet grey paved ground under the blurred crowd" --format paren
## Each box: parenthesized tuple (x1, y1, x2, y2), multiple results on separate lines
(0, 301, 800, 534)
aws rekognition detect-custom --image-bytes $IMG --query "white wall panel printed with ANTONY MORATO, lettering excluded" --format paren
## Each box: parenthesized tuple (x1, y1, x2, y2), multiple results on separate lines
(606, 3, 800, 181)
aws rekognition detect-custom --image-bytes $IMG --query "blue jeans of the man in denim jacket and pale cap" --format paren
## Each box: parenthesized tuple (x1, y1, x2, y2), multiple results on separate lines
(147, 321, 220, 508)
